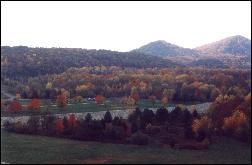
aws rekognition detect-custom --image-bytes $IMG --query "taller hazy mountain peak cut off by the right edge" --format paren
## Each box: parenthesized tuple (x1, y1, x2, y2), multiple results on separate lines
(195, 35, 251, 57)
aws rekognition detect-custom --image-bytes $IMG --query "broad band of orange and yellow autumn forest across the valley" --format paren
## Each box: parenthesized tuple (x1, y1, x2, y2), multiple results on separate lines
(2, 66, 251, 102)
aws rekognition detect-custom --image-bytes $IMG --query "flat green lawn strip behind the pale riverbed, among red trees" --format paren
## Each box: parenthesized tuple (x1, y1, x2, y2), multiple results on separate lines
(1, 99, 201, 116)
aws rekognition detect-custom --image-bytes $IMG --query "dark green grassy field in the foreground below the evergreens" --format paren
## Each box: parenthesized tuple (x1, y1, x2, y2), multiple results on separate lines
(1, 130, 251, 164)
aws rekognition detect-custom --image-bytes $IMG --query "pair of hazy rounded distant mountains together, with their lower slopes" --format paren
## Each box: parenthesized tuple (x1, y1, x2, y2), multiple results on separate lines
(132, 35, 251, 68)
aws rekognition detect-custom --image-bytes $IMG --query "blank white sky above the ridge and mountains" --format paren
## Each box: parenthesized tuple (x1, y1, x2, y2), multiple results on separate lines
(1, 1, 251, 51)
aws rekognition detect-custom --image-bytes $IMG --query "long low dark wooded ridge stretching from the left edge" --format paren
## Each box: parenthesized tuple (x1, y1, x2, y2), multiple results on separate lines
(1, 46, 181, 79)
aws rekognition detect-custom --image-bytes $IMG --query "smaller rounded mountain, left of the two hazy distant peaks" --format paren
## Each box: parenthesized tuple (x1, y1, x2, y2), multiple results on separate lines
(132, 40, 198, 57)
